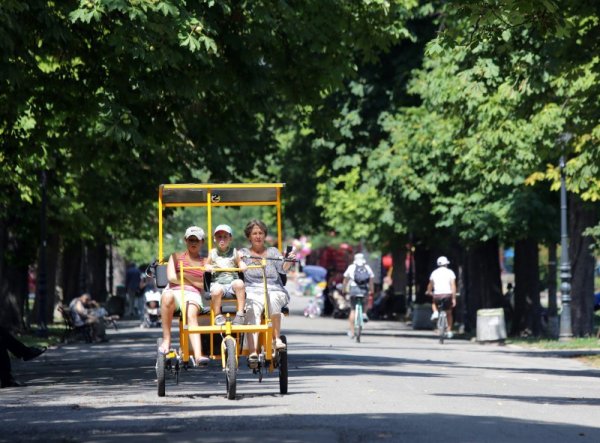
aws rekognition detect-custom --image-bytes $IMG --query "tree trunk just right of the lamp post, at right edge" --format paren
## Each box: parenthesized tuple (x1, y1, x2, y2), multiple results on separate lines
(569, 194, 598, 337)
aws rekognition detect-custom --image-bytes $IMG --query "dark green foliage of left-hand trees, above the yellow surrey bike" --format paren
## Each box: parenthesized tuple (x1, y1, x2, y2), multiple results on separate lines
(0, 0, 416, 268)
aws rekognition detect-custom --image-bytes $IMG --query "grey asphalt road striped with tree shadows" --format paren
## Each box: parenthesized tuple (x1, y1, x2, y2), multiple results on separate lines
(0, 297, 600, 443)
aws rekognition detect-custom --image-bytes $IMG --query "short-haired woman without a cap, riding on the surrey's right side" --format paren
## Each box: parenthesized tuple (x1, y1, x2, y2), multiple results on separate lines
(240, 219, 296, 363)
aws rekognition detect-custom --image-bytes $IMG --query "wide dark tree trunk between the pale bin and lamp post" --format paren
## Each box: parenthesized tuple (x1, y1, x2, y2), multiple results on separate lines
(511, 238, 542, 337)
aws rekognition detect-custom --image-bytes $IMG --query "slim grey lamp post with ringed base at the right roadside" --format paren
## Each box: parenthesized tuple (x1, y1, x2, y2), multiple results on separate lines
(559, 155, 573, 340)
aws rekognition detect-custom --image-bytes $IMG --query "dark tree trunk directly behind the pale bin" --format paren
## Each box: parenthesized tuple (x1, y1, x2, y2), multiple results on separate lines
(464, 239, 502, 331)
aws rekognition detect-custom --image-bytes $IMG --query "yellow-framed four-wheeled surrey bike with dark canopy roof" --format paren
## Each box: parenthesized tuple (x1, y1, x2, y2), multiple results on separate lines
(155, 183, 288, 400)
